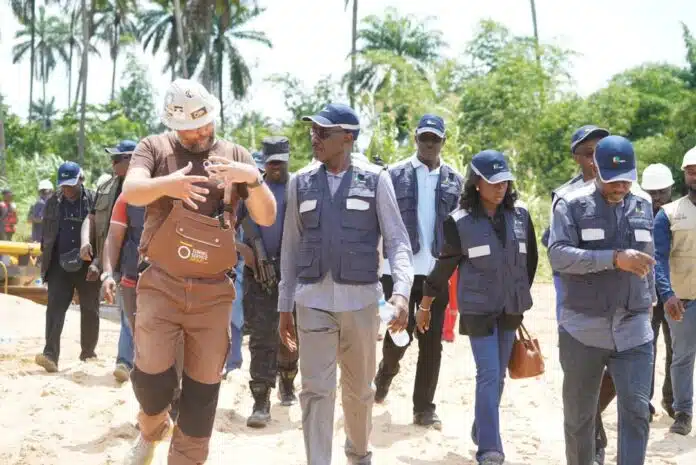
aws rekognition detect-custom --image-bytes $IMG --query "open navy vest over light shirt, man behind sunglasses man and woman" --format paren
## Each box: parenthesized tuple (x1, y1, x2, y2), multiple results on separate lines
(392, 158, 463, 257)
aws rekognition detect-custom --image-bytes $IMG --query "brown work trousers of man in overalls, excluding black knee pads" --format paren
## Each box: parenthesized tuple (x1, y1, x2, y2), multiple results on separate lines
(135, 265, 235, 465)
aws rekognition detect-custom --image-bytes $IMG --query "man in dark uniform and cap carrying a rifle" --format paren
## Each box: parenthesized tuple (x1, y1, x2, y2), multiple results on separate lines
(238, 136, 299, 428)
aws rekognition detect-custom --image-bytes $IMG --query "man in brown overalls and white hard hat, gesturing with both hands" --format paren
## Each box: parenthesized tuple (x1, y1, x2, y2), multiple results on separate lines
(123, 79, 276, 465)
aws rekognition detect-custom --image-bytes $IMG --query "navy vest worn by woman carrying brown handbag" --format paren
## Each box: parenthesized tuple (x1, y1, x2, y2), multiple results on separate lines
(451, 204, 532, 315)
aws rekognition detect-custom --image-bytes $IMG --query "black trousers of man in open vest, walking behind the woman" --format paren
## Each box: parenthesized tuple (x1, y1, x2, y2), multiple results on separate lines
(380, 275, 449, 413)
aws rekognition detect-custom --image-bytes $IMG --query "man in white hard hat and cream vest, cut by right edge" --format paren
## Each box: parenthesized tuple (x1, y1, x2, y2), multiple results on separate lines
(654, 147, 696, 436)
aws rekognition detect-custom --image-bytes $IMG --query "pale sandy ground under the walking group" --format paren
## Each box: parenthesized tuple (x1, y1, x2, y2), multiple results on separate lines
(0, 285, 696, 465)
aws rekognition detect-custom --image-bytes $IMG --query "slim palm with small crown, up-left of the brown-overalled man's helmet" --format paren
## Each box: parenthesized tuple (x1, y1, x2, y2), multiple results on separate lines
(94, 0, 138, 101)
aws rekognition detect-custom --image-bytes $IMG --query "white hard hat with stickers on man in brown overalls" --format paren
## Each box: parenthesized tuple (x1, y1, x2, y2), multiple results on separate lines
(160, 79, 220, 131)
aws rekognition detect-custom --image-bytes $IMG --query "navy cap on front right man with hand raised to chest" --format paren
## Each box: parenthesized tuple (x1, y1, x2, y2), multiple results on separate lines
(594, 136, 638, 182)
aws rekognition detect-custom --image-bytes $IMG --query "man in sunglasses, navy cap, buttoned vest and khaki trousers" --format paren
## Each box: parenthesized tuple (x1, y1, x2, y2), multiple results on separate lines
(278, 104, 413, 465)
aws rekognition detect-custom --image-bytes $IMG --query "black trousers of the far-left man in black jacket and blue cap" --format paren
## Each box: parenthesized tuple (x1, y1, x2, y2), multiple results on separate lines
(43, 260, 101, 363)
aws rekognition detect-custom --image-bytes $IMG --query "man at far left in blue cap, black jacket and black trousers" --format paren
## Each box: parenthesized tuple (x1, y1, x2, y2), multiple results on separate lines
(36, 161, 100, 373)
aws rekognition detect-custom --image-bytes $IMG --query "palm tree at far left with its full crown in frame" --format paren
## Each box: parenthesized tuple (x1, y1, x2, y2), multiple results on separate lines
(12, 6, 68, 118)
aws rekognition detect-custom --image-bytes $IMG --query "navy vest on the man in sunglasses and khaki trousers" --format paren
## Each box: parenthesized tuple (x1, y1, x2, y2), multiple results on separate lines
(296, 161, 382, 284)
